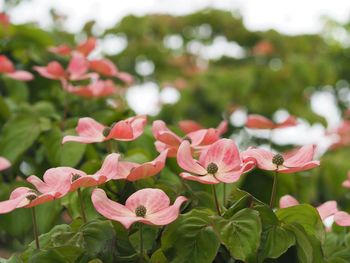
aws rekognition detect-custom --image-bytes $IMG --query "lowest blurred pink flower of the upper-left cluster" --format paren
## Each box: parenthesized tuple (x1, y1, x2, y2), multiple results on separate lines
(66, 80, 118, 98)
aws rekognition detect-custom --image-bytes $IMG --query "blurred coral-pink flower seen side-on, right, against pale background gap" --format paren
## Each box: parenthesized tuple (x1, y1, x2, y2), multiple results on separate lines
(245, 114, 298, 130)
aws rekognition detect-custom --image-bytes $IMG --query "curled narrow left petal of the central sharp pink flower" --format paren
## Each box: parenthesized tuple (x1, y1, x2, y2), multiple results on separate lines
(177, 141, 207, 175)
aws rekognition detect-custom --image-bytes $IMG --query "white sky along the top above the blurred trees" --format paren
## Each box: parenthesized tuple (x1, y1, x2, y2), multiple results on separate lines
(0, 0, 350, 34)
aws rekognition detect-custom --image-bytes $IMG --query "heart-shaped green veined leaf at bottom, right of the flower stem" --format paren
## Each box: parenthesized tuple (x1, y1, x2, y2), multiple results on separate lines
(214, 208, 262, 262)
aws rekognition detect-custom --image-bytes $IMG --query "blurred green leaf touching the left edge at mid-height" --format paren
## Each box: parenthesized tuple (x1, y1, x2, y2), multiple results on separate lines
(0, 115, 40, 163)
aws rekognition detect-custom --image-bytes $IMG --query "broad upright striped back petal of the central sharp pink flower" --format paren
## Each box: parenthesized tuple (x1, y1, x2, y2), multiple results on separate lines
(201, 139, 241, 172)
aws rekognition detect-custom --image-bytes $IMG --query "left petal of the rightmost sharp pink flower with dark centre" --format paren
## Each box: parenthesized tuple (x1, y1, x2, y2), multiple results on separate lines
(242, 148, 276, 171)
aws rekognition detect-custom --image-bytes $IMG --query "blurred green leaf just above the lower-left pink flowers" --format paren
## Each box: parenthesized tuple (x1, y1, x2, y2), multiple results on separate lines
(43, 128, 86, 167)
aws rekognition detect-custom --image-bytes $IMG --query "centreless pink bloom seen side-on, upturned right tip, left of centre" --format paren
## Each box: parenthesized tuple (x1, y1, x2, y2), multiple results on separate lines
(116, 150, 167, 181)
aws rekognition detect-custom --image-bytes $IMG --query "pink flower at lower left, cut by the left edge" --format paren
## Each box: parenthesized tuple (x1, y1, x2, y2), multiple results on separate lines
(0, 187, 60, 214)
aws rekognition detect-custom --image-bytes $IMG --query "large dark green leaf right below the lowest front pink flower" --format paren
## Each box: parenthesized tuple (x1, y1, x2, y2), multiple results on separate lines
(161, 209, 220, 263)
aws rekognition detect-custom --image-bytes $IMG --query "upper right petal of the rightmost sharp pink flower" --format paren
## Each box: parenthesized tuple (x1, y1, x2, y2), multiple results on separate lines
(283, 145, 316, 167)
